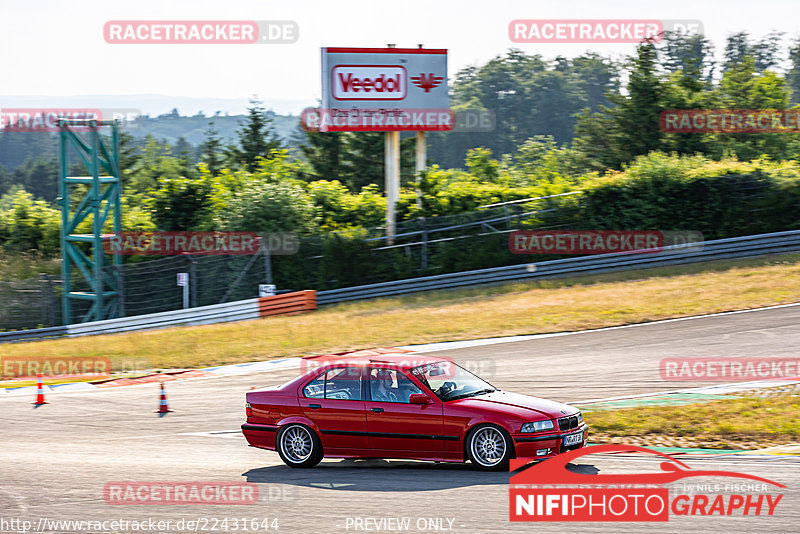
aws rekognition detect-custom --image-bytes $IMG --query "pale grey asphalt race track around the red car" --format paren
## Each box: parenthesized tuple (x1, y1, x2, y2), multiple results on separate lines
(0, 306, 800, 533)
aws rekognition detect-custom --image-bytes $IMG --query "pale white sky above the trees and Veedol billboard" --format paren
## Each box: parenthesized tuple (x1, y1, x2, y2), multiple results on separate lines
(0, 0, 800, 114)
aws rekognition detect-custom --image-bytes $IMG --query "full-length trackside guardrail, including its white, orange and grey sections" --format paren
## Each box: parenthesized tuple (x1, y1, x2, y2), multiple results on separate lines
(0, 230, 800, 343)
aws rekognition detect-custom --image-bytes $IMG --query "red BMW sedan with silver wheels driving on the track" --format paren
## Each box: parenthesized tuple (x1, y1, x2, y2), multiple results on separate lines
(242, 355, 588, 470)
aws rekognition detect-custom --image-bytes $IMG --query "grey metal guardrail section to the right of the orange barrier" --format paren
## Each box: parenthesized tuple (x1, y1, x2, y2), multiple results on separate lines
(317, 230, 800, 305)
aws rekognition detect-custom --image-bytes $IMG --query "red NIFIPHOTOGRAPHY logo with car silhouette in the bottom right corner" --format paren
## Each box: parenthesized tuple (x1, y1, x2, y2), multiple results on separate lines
(508, 445, 786, 522)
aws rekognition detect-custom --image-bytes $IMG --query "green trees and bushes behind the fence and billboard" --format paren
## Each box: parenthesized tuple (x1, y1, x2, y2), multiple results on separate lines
(0, 32, 800, 287)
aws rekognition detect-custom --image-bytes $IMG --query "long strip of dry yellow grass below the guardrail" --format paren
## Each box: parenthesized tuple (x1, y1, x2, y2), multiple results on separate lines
(2, 254, 800, 369)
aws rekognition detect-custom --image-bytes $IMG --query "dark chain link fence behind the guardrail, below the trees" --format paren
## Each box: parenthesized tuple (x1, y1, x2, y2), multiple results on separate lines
(0, 197, 584, 331)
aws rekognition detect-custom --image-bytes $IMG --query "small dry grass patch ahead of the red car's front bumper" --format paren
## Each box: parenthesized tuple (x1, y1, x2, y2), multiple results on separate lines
(586, 390, 800, 449)
